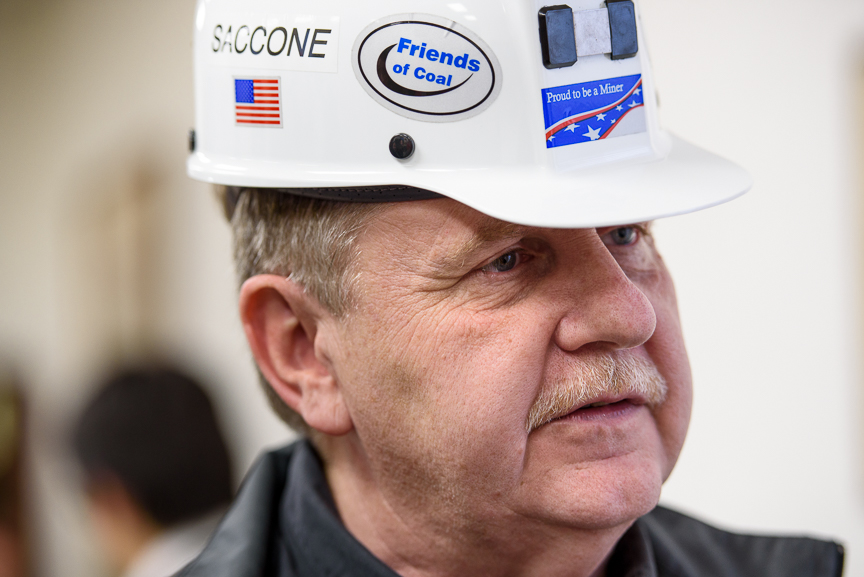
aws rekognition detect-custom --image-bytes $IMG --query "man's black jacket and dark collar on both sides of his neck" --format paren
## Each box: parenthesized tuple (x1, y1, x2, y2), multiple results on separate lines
(177, 441, 843, 577)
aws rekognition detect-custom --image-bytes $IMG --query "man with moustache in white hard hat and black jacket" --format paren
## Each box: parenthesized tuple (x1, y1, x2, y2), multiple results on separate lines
(181, 0, 842, 577)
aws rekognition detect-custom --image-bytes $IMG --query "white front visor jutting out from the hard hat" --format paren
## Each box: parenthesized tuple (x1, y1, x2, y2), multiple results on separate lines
(408, 133, 753, 228)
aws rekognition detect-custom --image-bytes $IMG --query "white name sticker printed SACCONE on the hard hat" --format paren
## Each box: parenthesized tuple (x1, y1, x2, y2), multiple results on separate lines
(209, 15, 339, 73)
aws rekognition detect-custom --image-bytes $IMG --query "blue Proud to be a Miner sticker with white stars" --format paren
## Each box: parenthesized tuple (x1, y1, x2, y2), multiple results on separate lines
(541, 74, 647, 148)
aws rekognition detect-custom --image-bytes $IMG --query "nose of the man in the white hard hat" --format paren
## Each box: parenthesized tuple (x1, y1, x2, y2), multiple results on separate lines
(554, 235, 657, 351)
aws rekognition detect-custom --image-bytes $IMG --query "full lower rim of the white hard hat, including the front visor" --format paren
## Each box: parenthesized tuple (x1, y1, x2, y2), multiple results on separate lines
(187, 132, 752, 228)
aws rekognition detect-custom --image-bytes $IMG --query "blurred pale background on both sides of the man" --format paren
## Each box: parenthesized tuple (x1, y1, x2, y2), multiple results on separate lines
(0, 0, 864, 577)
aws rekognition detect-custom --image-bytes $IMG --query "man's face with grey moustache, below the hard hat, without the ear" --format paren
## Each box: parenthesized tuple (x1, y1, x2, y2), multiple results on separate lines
(320, 199, 691, 533)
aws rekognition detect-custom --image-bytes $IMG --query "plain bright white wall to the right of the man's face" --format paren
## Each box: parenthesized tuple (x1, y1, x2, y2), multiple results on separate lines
(645, 0, 864, 575)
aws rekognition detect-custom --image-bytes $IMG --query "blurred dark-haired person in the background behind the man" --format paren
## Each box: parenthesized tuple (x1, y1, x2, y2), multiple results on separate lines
(73, 369, 233, 577)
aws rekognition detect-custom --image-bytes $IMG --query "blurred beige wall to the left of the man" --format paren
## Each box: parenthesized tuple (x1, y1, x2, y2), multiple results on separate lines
(0, 0, 288, 577)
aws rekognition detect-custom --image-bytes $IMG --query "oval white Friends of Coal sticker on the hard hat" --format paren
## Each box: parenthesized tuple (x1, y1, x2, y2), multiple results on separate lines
(352, 14, 501, 122)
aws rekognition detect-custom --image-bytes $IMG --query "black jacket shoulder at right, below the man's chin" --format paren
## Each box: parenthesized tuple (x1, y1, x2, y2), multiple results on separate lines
(638, 507, 843, 577)
